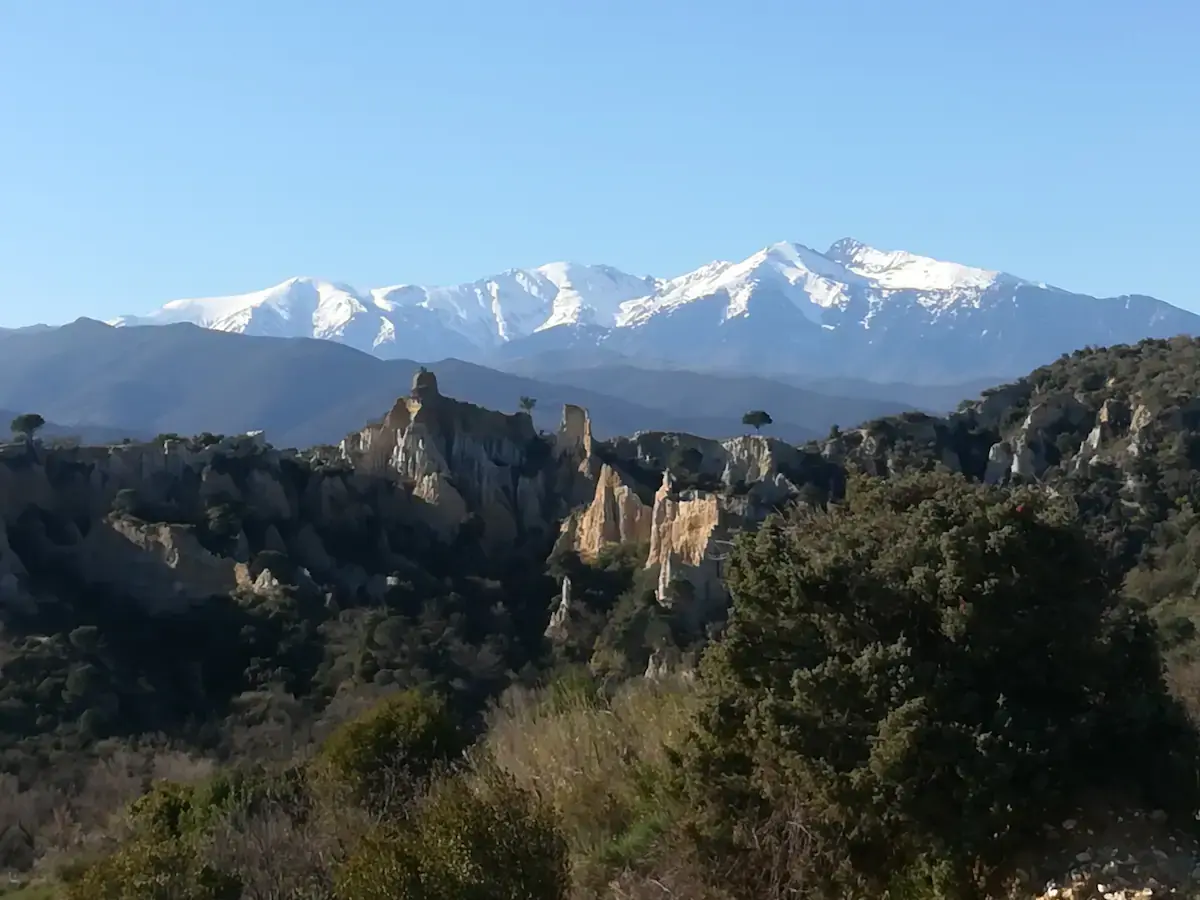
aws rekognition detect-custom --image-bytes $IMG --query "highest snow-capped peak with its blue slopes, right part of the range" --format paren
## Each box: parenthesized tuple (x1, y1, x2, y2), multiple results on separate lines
(590, 240, 1200, 383)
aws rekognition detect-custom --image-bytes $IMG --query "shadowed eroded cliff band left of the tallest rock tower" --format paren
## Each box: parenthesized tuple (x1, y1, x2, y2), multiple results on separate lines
(0, 436, 422, 613)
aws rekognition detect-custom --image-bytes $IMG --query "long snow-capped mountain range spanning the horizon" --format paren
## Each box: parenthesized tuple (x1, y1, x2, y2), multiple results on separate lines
(112, 239, 1200, 382)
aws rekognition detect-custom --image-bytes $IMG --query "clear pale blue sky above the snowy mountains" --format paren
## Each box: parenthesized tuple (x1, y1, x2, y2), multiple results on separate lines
(0, 0, 1200, 325)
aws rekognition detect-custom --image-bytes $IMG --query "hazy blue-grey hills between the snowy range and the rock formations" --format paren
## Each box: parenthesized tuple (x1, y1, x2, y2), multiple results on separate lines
(0, 319, 896, 446)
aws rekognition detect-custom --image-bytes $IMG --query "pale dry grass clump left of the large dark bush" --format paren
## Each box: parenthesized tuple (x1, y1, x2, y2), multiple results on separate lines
(484, 679, 695, 896)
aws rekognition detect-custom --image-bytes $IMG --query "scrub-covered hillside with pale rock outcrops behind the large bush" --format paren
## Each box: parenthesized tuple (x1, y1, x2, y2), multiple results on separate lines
(822, 337, 1200, 564)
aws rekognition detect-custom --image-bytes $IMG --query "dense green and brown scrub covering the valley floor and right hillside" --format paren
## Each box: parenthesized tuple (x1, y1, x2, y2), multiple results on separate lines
(7, 341, 1200, 900)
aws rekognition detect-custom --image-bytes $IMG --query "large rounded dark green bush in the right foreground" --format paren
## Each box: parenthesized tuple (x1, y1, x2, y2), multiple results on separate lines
(686, 474, 1195, 896)
